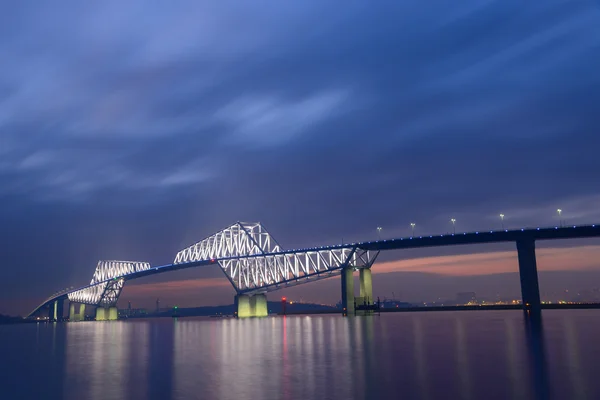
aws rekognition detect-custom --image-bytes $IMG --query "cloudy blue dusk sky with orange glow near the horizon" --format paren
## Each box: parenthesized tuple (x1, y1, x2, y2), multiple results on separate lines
(0, 0, 600, 314)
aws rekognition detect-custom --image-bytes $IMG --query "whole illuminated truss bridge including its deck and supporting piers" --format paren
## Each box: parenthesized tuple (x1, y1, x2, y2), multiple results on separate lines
(28, 222, 600, 321)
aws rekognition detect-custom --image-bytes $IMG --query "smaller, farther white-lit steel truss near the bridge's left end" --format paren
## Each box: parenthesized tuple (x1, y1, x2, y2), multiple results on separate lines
(68, 261, 151, 307)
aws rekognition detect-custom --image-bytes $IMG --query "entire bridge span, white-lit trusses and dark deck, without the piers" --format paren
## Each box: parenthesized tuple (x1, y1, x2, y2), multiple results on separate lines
(29, 222, 600, 317)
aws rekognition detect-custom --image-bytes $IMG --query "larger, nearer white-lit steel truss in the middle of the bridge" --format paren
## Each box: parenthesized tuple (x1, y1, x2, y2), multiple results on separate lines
(174, 222, 375, 293)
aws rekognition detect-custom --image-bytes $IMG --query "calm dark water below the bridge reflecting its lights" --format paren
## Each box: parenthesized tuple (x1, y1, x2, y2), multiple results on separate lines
(0, 310, 600, 400)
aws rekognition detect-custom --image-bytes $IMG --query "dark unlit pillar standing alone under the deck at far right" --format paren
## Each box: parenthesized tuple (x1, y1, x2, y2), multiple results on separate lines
(517, 239, 542, 313)
